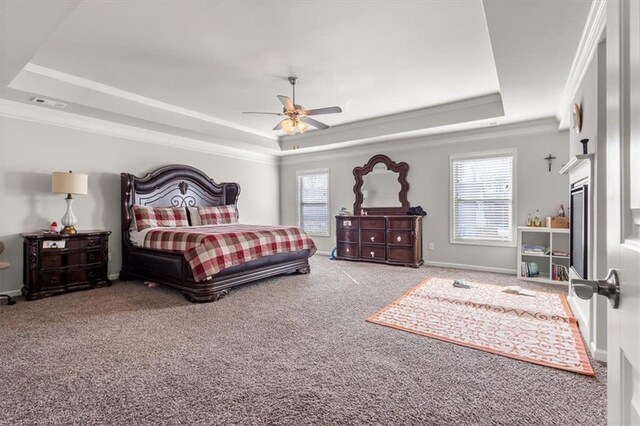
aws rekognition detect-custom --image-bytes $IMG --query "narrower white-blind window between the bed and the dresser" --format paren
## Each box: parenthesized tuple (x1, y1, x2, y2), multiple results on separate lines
(298, 169, 329, 237)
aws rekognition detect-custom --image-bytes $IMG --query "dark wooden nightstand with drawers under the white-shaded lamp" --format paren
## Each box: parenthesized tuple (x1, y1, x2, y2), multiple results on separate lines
(20, 230, 111, 300)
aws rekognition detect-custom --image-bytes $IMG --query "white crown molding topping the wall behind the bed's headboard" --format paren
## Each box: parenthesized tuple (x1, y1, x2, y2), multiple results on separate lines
(0, 99, 279, 165)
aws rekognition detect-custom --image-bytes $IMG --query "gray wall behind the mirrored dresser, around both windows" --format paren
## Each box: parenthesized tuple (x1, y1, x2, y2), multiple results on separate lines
(280, 126, 569, 272)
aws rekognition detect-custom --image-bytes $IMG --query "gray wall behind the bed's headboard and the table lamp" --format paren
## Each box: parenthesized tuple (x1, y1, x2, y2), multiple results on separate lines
(0, 117, 279, 292)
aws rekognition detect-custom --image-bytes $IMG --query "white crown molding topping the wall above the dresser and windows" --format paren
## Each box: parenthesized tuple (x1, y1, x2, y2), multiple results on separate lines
(280, 117, 559, 166)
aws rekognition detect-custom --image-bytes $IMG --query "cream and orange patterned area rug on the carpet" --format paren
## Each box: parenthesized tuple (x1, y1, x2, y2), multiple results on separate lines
(367, 278, 594, 376)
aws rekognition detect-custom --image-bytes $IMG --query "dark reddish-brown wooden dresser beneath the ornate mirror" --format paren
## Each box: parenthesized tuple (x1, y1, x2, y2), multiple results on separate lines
(336, 215, 424, 268)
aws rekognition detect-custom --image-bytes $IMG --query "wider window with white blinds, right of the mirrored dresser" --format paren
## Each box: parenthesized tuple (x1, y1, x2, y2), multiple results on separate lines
(451, 152, 515, 246)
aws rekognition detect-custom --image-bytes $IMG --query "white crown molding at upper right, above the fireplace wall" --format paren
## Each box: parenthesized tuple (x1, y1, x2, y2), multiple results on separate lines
(556, 0, 607, 129)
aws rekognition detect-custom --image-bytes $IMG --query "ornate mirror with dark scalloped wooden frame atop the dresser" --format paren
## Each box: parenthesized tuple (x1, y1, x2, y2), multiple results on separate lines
(353, 154, 409, 215)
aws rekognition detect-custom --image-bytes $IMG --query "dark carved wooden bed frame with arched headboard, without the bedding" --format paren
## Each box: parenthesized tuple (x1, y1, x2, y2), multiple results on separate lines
(120, 165, 315, 302)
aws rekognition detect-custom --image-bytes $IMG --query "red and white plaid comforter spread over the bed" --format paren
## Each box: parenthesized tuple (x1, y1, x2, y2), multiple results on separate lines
(144, 224, 316, 281)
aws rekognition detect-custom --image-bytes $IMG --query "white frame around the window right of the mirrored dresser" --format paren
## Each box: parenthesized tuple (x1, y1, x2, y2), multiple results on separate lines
(449, 148, 518, 247)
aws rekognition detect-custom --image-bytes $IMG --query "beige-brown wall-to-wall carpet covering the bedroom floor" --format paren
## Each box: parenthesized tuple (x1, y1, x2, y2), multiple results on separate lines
(0, 256, 606, 425)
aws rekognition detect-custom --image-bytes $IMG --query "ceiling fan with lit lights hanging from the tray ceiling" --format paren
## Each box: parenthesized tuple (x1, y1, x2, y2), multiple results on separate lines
(243, 77, 342, 135)
